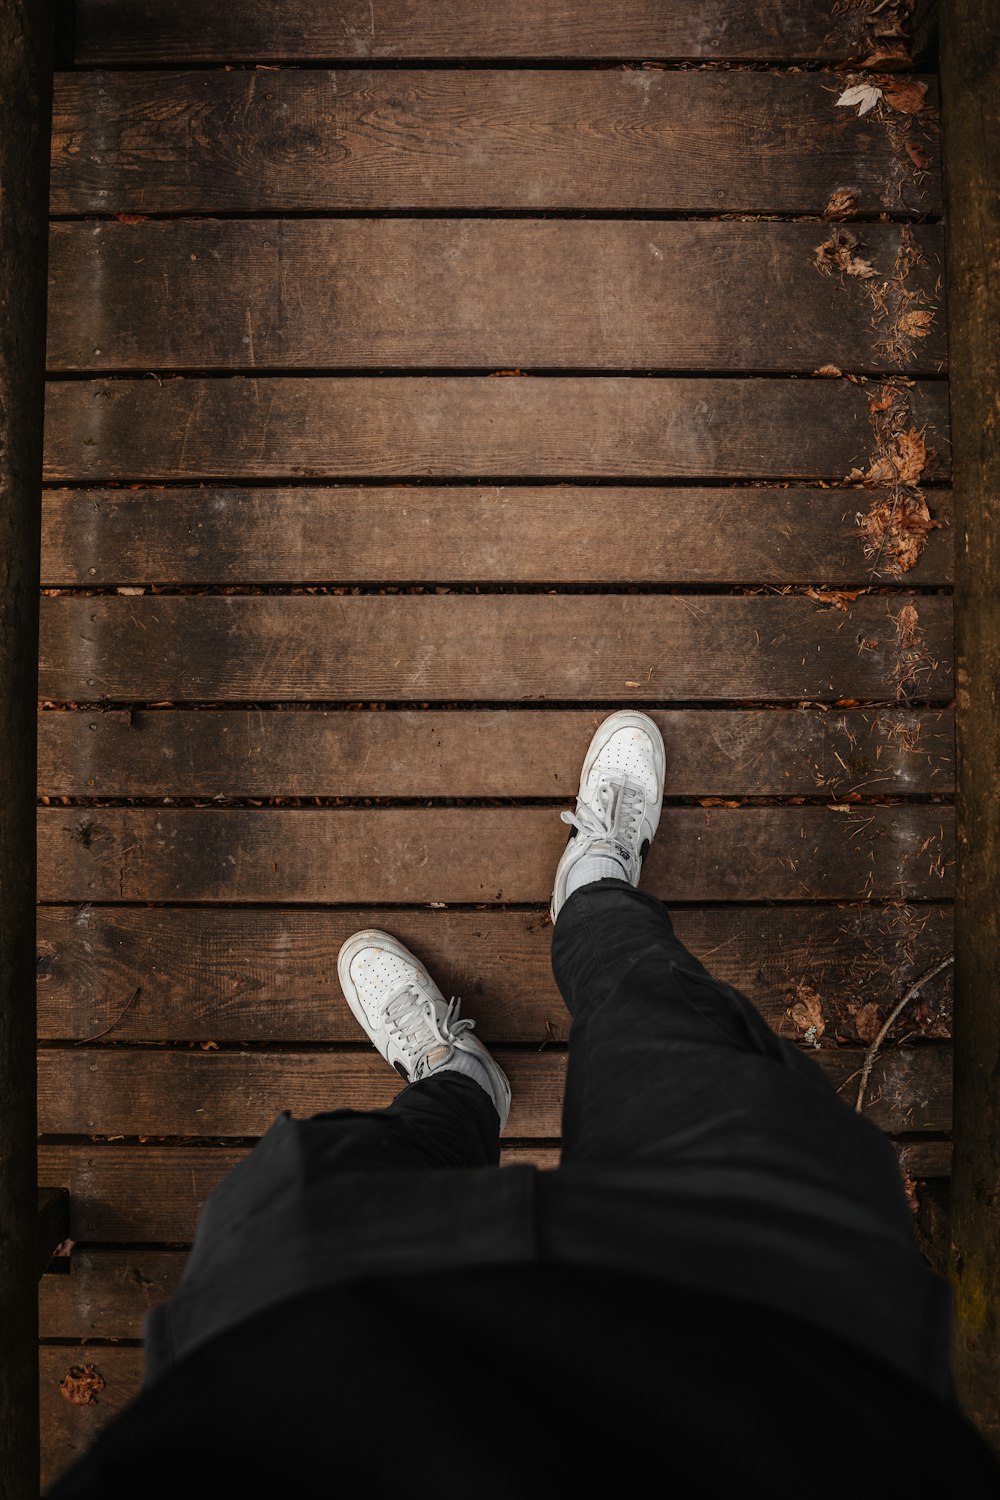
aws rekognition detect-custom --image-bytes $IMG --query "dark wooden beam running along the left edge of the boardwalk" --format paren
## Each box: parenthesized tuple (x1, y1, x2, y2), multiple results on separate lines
(0, 0, 52, 1500)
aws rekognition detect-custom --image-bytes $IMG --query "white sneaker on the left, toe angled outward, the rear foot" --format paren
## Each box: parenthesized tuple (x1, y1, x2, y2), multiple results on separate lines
(337, 929, 510, 1130)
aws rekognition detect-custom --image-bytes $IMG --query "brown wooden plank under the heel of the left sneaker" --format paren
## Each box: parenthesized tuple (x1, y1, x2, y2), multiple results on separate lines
(39, 1038, 952, 1134)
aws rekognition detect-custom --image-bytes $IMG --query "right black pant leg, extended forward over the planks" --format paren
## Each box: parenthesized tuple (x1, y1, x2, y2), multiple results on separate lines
(547, 881, 951, 1394)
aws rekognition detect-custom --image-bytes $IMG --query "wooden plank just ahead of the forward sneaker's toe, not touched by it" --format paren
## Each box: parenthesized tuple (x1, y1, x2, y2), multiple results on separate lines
(39, 594, 952, 704)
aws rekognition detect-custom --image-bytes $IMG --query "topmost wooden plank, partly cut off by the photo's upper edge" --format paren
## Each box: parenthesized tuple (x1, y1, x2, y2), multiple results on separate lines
(73, 0, 893, 66)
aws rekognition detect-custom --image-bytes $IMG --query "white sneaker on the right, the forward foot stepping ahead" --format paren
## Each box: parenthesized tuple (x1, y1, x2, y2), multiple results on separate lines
(549, 710, 667, 923)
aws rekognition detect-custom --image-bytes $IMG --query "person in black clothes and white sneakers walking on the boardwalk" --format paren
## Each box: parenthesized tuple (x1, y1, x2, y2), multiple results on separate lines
(48, 711, 1000, 1500)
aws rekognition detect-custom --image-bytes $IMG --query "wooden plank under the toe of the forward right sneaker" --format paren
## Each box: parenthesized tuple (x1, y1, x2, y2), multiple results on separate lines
(37, 708, 954, 800)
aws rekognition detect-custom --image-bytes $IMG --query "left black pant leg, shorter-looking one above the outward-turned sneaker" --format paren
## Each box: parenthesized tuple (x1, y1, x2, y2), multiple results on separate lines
(145, 1073, 509, 1385)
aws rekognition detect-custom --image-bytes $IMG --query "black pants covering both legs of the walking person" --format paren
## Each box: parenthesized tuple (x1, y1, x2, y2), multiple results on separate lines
(147, 881, 951, 1395)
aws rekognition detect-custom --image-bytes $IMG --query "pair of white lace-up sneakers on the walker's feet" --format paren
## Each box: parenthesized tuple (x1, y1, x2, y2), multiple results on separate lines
(337, 711, 666, 1130)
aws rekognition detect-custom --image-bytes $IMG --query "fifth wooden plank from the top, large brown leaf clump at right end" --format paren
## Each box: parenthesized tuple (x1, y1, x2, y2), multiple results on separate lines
(42, 485, 954, 587)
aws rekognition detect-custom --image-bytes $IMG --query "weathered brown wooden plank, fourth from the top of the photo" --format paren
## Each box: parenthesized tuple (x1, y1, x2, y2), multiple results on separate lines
(43, 375, 949, 482)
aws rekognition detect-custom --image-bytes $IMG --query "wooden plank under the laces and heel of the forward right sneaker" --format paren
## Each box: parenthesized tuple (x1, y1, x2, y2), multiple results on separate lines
(37, 789, 954, 905)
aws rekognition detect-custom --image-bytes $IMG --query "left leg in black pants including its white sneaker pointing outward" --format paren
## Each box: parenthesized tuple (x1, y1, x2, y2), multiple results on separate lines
(145, 932, 515, 1383)
